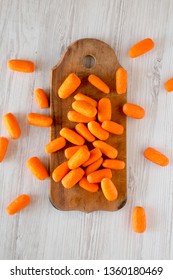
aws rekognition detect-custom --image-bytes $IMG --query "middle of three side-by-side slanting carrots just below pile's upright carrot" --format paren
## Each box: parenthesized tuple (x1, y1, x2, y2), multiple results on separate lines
(88, 121, 109, 140)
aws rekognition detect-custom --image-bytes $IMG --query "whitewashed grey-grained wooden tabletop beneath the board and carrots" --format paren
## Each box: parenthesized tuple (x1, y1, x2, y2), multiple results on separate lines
(0, 0, 173, 260)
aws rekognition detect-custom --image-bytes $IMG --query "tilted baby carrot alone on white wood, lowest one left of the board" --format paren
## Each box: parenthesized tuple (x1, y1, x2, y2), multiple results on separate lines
(6, 194, 31, 215)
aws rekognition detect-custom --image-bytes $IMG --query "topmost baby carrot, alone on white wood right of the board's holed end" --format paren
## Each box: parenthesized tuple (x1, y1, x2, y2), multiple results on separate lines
(129, 38, 154, 58)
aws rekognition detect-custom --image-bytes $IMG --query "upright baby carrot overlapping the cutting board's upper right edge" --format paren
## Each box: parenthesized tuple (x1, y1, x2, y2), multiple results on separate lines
(115, 67, 127, 94)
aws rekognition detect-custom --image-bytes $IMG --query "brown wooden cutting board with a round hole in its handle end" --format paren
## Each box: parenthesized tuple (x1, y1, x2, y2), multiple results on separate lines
(49, 39, 127, 212)
